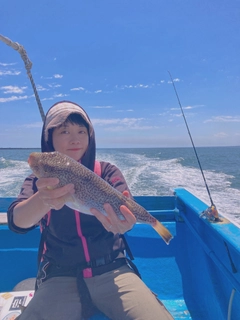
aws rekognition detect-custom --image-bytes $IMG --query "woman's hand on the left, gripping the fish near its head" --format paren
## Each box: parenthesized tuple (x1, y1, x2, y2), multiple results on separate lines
(36, 178, 74, 210)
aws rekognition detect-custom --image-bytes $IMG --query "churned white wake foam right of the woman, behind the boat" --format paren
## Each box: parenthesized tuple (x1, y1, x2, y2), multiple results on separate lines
(96, 152, 240, 226)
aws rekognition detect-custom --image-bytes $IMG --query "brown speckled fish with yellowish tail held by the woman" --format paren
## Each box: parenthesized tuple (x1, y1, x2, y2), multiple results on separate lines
(28, 152, 173, 244)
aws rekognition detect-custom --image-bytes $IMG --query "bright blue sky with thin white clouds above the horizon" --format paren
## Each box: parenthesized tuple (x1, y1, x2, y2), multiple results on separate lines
(0, 0, 240, 148)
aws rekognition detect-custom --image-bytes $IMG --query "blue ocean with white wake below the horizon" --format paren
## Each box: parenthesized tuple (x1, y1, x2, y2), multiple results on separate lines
(0, 147, 240, 226)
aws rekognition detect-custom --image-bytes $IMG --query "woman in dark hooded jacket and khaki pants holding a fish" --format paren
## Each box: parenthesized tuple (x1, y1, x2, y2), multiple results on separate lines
(8, 101, 173, 320)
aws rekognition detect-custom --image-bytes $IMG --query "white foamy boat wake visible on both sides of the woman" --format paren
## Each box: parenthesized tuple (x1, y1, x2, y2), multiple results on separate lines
(0, 149, 240, 226)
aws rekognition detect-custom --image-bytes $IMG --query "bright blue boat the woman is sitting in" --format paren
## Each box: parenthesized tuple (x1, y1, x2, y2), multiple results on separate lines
(0, 188, 240, 320)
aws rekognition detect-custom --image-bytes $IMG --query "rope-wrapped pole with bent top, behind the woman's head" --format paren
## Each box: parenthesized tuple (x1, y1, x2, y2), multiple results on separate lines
(0, 34, 45, 122)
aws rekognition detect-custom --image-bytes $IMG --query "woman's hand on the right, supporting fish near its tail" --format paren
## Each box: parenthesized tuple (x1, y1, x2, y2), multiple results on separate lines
(91, 191, 136, 234)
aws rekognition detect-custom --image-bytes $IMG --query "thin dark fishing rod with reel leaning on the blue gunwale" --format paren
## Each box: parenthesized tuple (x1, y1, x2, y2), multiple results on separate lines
(168, 71, 218, 220)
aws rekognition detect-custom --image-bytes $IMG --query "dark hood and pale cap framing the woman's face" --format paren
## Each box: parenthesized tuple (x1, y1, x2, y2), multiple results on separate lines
(41, 101, 96, 171)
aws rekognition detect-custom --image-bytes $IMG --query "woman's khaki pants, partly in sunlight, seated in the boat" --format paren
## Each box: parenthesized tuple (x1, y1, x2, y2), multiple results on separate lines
(20, 266, 173, 320)
